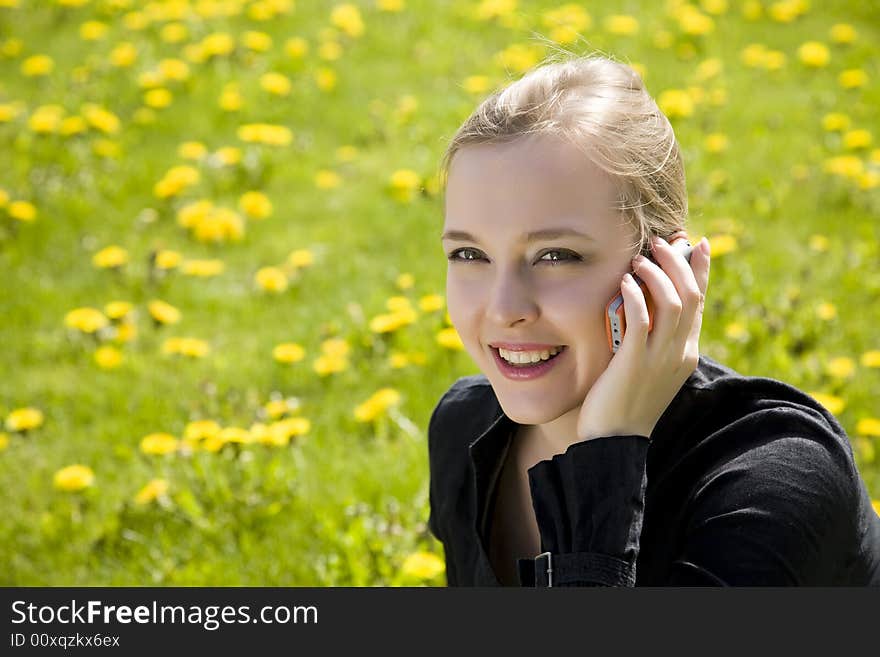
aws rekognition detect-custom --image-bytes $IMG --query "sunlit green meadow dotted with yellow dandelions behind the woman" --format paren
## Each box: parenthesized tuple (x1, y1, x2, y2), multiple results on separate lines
(0, 0, 880, 586)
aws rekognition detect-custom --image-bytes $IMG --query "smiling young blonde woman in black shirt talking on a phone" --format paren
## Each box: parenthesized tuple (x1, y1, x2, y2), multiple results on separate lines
(429, 52, 880, 586)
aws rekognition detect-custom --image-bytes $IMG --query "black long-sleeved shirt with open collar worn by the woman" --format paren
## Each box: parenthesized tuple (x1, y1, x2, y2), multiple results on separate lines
(428, 356, 880, 586)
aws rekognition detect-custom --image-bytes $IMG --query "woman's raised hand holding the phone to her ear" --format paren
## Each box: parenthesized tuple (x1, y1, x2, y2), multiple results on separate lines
(577, 235, 709, 440)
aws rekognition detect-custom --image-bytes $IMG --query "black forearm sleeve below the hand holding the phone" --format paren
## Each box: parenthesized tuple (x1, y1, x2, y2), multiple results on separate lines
(528, 435, 650, 586)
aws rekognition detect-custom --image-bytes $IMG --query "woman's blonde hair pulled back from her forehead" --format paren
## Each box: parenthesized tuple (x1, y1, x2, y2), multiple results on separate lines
(440, 54, 688, 255)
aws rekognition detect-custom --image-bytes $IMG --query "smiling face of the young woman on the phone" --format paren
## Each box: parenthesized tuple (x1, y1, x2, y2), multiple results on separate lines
(442, 135, 636, 424)
